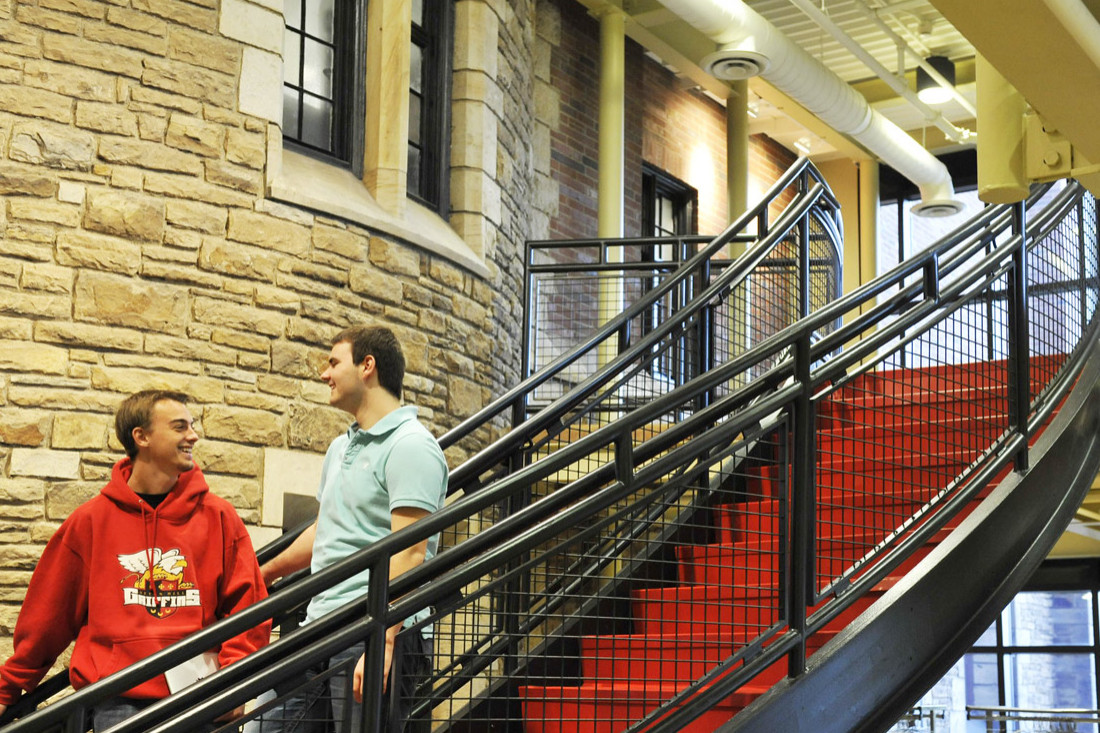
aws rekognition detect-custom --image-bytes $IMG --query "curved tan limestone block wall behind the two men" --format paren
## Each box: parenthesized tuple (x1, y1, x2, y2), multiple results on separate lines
(0, 0, 534, 656)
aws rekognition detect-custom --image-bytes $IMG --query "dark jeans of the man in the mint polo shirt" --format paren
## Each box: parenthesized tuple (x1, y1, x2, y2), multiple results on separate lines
(260, 632, 432, 733)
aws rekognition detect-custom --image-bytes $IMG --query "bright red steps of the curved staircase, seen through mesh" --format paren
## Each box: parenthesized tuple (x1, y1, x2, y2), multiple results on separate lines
(519, 362, 1042, 733)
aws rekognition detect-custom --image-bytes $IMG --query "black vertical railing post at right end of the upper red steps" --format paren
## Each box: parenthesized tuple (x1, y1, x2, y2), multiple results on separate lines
(1009, 201, 1031, 471)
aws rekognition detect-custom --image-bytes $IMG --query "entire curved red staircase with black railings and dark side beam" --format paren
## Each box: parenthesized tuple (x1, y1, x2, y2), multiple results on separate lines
(6, 162, 1100, 733)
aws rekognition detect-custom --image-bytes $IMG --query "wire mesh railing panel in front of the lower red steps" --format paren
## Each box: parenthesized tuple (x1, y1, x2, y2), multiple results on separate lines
(420, 429, 789, 731)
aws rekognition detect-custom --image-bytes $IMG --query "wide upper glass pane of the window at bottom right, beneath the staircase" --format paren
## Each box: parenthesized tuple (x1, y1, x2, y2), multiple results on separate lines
(1002, 591, 1092, 646)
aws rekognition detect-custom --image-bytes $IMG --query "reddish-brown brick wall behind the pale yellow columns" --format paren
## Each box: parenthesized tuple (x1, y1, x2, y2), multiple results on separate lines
(540, 0, 796, 239)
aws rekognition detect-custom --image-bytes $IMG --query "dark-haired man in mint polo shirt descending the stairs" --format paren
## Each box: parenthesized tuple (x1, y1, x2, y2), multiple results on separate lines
(261, 326, 447, 733)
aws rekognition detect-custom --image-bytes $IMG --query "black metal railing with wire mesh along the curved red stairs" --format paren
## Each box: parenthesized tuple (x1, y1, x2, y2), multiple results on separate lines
(4, 168, 1100, 732)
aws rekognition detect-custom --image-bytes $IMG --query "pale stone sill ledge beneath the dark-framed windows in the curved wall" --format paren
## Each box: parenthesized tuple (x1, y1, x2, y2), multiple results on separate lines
(267, 149, 490, 277)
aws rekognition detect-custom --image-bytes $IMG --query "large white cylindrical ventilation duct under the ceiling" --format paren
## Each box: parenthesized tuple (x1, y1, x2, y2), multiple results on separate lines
(661, 0, 964, 217)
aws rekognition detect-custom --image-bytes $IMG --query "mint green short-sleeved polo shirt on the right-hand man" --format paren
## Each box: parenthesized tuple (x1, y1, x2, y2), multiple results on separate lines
(306, 406, 447, 624)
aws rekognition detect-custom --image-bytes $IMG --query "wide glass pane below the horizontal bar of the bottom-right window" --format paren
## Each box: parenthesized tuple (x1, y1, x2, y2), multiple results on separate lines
(1004, 654, 1097, 708)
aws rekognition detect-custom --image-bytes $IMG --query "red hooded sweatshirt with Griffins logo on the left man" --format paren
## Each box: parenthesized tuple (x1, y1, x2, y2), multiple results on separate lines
(0, 458, 271, 705)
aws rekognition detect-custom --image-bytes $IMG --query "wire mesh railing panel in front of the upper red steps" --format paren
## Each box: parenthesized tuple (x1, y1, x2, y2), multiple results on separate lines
(815, 341, 1008, 591)
